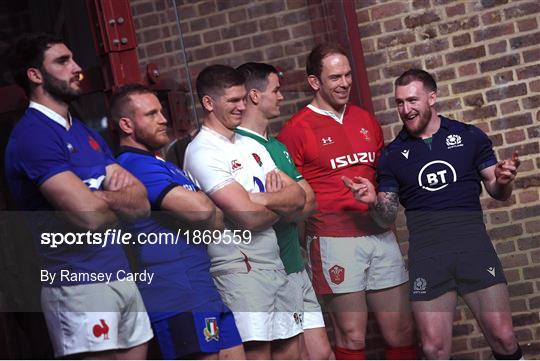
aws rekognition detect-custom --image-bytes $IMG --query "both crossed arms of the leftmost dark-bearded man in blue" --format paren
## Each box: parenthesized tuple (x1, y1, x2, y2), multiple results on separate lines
(40, 164, 150, 231)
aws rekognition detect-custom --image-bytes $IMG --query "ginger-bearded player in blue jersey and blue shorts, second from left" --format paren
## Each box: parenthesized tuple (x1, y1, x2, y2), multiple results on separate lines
(110, 84, 245, 360)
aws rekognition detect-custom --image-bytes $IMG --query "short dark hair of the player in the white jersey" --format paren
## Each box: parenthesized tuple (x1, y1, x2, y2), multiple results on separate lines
(197, 64, 246, 104)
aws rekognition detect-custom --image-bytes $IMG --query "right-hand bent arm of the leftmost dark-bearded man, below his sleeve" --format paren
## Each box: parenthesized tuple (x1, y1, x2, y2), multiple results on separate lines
(95, 164, 150, 219)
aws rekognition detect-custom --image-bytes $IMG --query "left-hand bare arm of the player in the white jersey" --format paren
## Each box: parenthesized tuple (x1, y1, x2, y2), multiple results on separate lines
(209, 182, 279, 231)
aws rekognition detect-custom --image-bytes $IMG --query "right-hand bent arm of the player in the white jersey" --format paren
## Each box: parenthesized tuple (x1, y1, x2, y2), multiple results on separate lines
(249, 172, 306, 216)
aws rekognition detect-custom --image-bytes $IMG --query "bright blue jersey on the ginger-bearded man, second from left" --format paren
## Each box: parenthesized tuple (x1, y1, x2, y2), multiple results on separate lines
(117, 147, 220, 322)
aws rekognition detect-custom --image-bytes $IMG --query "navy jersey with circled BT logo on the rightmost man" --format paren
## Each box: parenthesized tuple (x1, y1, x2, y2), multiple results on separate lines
(377, 116, 497, 255)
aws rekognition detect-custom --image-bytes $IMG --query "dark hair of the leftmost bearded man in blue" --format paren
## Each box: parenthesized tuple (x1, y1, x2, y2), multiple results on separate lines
(7, 33, 64, 96)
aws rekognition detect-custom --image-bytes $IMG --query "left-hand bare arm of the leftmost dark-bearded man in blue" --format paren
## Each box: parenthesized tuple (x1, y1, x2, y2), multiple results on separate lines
(40, 171, 117, 231)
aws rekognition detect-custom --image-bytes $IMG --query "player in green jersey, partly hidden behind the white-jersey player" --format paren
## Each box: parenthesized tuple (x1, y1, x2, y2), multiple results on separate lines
(235, 63, 333, 360)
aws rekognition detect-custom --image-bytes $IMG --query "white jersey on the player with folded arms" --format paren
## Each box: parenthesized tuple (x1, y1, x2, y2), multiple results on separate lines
(184, 126, 284, 274)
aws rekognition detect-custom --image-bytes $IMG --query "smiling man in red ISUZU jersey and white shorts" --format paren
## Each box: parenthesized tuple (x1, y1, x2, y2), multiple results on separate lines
(278, 44, 416, 359)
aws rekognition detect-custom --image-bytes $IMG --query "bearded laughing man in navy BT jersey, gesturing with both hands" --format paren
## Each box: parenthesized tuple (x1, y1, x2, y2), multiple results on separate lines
(344, 69, 522, 360)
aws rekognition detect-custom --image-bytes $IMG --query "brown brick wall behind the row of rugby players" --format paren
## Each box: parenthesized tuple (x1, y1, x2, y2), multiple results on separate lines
(131, 0, 540, 359)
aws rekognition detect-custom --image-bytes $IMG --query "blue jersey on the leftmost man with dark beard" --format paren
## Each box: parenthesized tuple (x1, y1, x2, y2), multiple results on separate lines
(5, 108, 128, 285)
